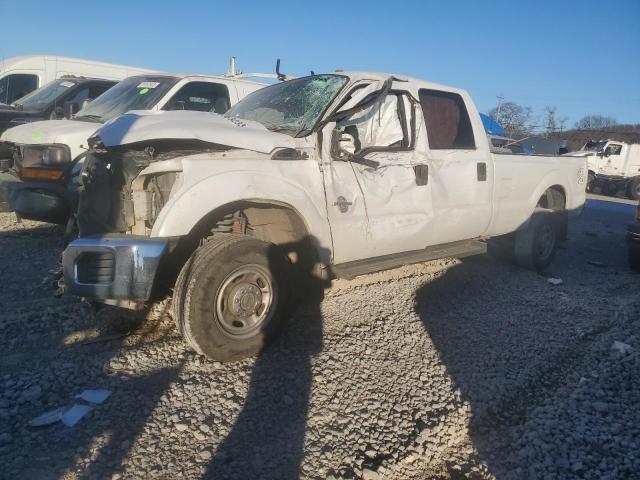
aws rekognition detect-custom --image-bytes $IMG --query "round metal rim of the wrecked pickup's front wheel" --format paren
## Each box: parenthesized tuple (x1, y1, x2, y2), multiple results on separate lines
(215, 264, 278, 338)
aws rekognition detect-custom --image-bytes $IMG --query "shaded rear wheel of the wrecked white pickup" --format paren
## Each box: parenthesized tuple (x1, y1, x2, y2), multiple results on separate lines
(513, 208, 561, 271)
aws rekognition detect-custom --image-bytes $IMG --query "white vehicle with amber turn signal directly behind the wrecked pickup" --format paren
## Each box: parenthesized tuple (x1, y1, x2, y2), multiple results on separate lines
(0, 74, 265, 225)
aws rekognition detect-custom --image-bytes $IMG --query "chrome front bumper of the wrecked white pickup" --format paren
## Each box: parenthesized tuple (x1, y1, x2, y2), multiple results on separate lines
(62, 234, 169, 302)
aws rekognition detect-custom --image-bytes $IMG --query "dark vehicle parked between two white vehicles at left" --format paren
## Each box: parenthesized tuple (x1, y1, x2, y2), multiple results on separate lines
(0, 77, 117, 134)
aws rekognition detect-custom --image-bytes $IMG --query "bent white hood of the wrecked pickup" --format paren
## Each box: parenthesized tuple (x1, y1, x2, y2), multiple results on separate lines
(95, 110, 296, 153)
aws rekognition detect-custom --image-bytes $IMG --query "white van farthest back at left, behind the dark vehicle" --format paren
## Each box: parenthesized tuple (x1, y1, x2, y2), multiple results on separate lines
(0, 55, 153, 105)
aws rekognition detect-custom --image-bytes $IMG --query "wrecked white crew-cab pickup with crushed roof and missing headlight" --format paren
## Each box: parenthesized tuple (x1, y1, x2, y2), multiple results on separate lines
(63, 72, 587, 360)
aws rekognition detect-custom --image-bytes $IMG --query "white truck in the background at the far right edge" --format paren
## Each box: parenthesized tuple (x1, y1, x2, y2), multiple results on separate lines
(568, 140, 640, 200)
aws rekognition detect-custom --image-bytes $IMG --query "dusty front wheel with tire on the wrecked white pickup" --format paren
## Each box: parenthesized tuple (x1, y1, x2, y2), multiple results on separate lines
(173, 235, 289, 362)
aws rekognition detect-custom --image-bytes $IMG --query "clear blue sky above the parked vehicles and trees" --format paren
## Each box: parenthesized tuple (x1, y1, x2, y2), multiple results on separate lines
(0, 0, 640, 124)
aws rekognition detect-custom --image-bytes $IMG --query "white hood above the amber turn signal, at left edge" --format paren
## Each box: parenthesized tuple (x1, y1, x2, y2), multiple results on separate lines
(0, 120, 101, 158)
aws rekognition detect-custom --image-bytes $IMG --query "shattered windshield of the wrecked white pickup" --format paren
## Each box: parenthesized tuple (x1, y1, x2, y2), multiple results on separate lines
(225, 75, 348, 136)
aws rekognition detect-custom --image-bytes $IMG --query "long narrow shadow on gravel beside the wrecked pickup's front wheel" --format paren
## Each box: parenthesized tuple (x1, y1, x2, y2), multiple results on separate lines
(204, 237, 327, 479)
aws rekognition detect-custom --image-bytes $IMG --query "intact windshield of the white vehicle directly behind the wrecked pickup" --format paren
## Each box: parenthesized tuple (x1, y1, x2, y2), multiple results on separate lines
(75, 75, 178, 122)
